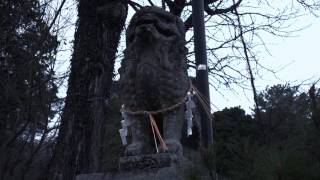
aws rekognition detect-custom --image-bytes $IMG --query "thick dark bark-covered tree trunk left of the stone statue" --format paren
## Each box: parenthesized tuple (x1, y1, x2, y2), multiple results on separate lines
(51, 0, 127, 180)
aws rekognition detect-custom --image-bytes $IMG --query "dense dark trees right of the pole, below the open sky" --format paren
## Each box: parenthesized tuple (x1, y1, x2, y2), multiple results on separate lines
(213, 85, 320, 180)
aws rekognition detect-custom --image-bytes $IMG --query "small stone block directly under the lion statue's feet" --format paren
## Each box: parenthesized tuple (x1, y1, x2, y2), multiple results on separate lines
(119, 153, 179, 171)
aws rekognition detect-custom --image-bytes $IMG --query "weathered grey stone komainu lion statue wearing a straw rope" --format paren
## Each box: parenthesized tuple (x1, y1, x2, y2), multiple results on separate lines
(119, 7, 189, 156)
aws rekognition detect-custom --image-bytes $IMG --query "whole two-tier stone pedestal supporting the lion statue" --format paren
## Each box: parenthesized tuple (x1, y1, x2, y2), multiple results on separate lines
(76, 153, 183, 180)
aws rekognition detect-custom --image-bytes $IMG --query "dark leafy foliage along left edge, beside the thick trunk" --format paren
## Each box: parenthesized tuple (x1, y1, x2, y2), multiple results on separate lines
(0, 0, 61, 179)
